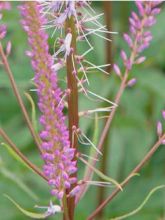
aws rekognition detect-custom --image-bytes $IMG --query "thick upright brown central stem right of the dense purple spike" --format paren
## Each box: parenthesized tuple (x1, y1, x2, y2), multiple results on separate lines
(66, 16, 78, 220)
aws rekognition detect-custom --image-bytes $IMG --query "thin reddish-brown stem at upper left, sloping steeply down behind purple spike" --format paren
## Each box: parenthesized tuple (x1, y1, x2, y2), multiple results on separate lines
(0, 43, 42, 153)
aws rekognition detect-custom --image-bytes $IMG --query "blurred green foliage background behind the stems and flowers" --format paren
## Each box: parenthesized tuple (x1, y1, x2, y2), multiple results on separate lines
(0, 1, 165, 220)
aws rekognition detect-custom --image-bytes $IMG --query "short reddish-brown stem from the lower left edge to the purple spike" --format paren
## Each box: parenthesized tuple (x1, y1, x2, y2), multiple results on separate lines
(0, 128, 48, 181)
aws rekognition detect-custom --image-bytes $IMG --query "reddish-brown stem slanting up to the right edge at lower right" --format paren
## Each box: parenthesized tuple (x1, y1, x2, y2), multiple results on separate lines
(88, 134, 165, 220)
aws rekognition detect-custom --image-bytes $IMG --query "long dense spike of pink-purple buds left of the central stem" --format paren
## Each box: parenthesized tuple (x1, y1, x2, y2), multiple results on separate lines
(20, 2, 77, 199)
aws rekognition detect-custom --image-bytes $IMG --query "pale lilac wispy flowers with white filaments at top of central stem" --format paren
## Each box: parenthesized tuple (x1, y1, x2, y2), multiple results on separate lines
(41, 0, 112, 81)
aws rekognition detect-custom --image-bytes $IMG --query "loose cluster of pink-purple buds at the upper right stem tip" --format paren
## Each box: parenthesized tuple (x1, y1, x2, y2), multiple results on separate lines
(114, 1, 161, 75)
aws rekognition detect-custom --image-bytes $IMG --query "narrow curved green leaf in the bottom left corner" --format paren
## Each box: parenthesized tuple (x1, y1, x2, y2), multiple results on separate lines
(4, 194, 49, 219)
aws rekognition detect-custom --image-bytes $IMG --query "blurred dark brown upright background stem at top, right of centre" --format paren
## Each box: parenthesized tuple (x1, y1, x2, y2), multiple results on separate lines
(103, 1, 113, 72)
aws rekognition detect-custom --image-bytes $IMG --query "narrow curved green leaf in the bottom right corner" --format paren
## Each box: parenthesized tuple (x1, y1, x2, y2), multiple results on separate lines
(110, 185, 165, 220)
